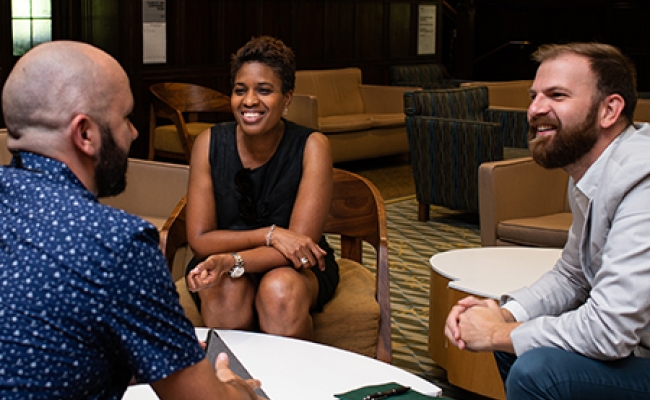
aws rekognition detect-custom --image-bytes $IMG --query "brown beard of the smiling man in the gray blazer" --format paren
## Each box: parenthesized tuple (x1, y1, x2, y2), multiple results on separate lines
(528, 101, 599, 168)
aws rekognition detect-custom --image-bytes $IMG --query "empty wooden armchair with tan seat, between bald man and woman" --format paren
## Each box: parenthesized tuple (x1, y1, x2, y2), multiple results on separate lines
(149, 83, 231, 162)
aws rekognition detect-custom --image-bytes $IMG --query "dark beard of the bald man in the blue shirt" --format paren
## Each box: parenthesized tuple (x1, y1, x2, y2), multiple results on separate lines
(95, 125, 129, 197)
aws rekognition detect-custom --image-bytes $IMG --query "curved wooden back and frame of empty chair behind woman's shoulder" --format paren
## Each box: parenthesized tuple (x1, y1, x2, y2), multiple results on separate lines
(149, 82, 231, 162)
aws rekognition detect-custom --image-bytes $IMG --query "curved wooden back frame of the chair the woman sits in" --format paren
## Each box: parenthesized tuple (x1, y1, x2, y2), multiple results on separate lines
(160, 168, 392, 363)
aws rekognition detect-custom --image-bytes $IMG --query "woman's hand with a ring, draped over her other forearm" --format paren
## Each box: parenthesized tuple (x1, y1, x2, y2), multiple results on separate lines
(269, 227, 327, 271)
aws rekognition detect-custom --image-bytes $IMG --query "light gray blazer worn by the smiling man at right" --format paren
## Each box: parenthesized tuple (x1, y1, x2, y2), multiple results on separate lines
(509, 124, 650, 360)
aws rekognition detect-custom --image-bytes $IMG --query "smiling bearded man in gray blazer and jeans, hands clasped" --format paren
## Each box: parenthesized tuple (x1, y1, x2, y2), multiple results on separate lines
(445, 43, 650, 399)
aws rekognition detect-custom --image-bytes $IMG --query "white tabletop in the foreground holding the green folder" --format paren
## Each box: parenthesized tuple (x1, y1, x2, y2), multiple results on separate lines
(123, 328, 441, 400)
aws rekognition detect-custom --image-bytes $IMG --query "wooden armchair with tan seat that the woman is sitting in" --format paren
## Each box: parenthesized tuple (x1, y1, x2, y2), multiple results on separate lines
(161, 169, 392, 363)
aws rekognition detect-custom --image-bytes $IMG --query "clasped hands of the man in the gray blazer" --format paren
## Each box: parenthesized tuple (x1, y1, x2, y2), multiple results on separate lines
(445, 296, 519, 352)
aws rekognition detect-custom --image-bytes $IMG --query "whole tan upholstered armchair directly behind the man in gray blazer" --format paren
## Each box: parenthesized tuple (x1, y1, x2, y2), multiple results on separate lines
(478, 157, 573, 248)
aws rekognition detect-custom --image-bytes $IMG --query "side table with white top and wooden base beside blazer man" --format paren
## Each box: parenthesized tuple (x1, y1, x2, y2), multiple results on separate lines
(429, 247, 562, 399)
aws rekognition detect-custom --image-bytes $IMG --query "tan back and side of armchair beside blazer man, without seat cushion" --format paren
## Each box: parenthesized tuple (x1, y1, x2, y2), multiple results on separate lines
(478, 157, 568, 246)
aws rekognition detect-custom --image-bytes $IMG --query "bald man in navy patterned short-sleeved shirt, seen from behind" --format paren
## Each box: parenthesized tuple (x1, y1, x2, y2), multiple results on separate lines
(0, 42, 259, 399)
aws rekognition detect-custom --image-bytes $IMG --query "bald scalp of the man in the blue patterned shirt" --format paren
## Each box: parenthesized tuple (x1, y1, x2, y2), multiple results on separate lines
(2, 41, 128, 140)
